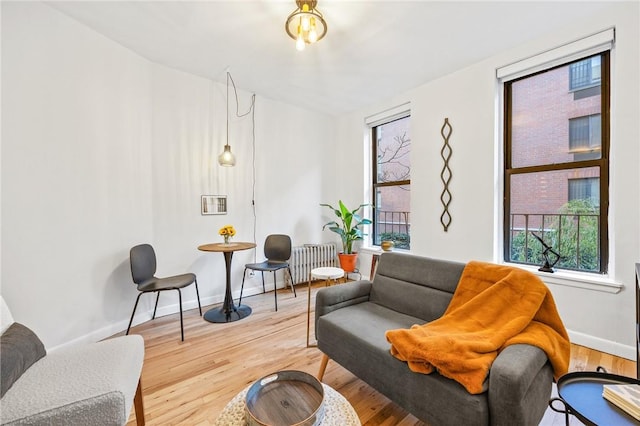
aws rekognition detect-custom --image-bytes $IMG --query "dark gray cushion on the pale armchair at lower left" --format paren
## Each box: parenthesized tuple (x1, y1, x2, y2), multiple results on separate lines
(0, 322, 47, 397)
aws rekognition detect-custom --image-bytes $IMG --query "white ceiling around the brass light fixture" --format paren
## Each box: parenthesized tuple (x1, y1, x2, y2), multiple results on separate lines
(47, 0, 611, 115)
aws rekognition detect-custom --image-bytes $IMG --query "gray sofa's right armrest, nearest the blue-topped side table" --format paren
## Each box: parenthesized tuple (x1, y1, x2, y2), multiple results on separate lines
(489, 344, 553, 425)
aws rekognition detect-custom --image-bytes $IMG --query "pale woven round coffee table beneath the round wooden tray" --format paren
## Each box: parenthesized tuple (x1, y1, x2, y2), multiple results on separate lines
(214, 383, 361, 426)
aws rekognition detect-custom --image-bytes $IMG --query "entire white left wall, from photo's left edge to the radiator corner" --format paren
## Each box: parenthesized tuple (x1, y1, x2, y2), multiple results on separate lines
(1, 2, 334, 349)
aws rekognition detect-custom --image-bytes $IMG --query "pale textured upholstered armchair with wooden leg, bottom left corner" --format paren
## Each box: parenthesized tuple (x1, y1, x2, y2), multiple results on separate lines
(0, 295, 145, 426)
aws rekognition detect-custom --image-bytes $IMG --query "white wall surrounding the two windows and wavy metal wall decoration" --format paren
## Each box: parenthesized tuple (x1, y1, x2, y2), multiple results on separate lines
(340, 2, 640, 359)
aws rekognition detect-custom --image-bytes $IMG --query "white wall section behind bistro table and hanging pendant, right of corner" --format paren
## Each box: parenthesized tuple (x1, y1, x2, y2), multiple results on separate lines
(153, 66, 333, 312)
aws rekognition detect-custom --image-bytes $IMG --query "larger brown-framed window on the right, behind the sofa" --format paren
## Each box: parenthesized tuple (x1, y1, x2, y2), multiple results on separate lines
(504, 51, 610, 273)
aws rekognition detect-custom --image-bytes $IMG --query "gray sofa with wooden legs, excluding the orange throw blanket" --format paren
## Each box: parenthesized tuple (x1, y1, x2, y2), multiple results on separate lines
(315, 253, 553, 426)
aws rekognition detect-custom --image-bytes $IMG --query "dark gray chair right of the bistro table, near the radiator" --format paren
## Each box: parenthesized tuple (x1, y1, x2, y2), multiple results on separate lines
(238, 234, 298, 311)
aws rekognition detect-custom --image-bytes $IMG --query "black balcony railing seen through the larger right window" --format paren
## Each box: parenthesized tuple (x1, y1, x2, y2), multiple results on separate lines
(507, 213, 600, 272)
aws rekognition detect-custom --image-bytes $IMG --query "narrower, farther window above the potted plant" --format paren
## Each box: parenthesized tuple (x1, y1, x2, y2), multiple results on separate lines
(371, 117, 411, 249)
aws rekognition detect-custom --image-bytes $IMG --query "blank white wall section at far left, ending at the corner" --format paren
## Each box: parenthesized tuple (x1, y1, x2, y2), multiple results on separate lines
(2, 3, 152, 346)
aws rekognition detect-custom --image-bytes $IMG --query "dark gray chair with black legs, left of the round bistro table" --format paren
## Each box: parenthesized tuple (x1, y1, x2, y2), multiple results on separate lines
(126, 244, 202, 341)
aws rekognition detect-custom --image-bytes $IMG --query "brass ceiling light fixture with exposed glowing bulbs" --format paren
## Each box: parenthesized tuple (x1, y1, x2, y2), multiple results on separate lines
(284, 0, 327, 50)
